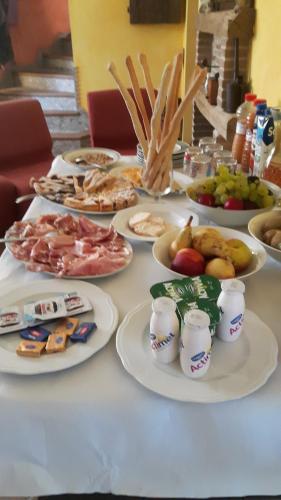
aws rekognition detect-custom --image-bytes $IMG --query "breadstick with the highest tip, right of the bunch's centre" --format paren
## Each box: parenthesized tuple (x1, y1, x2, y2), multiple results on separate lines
(161, 52, 183, 141)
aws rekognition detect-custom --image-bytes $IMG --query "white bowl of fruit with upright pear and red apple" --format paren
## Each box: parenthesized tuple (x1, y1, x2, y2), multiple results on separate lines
(152, 226, 266, 280)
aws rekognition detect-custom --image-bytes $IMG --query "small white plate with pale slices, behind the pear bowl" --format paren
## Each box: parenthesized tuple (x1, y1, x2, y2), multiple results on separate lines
(112, 203, 199, 242)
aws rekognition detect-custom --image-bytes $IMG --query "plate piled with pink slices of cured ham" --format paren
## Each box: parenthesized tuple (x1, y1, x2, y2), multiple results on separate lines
(5, 214, 133, 279)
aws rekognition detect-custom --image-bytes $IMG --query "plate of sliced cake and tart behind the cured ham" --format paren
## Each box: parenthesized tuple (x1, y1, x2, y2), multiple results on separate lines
(30, 170, 139, 215)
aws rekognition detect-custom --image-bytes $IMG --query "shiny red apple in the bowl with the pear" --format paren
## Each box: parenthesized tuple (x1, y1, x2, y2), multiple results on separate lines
(171, 248, 205, 276)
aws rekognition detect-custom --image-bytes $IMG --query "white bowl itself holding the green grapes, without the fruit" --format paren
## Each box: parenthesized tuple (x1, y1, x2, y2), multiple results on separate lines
(185, 177, 281, 227)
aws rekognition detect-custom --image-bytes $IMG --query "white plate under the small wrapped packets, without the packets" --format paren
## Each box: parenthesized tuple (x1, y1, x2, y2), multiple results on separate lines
(0, 280, 118, 375)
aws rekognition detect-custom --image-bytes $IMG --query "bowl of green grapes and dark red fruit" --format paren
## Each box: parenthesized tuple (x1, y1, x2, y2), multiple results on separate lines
(187, 166, 281, 227)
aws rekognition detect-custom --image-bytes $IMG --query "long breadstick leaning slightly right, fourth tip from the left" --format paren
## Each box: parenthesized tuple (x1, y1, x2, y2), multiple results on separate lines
(143, 63, 172, 179)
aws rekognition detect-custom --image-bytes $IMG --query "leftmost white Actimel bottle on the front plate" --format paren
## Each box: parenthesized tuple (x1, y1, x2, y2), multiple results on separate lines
(150, 297, 179, 363)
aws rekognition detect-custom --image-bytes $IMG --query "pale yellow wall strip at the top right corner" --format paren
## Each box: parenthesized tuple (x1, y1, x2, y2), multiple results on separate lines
(251, 0, 281, 106)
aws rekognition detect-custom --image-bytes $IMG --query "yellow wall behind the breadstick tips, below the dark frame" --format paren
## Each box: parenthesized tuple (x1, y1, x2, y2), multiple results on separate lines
(69, 0, 184, 107)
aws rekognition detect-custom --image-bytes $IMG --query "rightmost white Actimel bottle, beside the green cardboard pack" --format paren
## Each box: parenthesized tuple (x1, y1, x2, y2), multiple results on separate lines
(216, 279, 245, 342)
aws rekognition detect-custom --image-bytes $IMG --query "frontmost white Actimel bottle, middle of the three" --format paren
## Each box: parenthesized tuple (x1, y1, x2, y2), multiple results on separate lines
(180, 309, 212, 378)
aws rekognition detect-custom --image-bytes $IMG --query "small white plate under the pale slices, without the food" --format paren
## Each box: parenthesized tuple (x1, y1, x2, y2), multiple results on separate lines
(112, 203, 199, 242)
